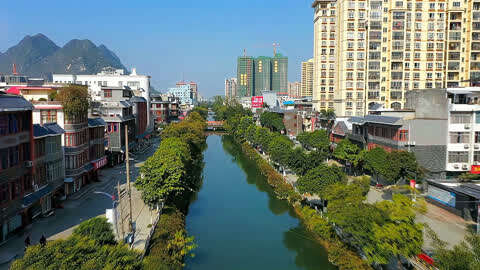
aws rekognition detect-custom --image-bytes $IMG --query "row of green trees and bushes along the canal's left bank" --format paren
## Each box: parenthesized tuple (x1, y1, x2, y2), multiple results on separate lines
(135, 110, 206, 270)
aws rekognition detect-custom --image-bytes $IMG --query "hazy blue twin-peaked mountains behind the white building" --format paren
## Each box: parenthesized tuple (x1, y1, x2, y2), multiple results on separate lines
(0, 34, 126, 79)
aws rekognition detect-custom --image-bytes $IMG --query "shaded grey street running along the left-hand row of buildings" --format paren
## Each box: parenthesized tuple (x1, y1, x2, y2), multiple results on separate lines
(0, 139, 159, 270)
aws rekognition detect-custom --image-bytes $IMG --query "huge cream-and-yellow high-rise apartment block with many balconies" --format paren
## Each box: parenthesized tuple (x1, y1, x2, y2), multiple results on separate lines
(312, 0, 480, 116)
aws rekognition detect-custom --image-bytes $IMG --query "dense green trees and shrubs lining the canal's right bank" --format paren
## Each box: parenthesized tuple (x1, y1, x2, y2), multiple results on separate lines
(212, 98, 423, 269)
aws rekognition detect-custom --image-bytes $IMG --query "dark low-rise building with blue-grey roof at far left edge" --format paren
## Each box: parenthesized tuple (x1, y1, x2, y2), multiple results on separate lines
(0, 93, 34, 241)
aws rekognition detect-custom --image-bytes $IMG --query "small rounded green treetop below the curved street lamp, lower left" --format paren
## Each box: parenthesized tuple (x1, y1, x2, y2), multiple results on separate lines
(73, 217, 116, 245)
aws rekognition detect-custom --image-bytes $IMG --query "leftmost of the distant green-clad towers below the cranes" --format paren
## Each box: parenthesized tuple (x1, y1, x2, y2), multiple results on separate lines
(237, 56, 254, 97)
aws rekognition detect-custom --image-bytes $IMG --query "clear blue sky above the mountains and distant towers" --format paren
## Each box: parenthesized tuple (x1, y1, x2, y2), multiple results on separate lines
(0, 0, 313, 97)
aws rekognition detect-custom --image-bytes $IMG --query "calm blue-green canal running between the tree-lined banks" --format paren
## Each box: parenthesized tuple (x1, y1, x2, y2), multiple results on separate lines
(186, 135, 336, 270)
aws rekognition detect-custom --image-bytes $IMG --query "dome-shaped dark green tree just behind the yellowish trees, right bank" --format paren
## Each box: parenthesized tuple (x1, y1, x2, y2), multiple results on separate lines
(297, 164, 347, 197)
